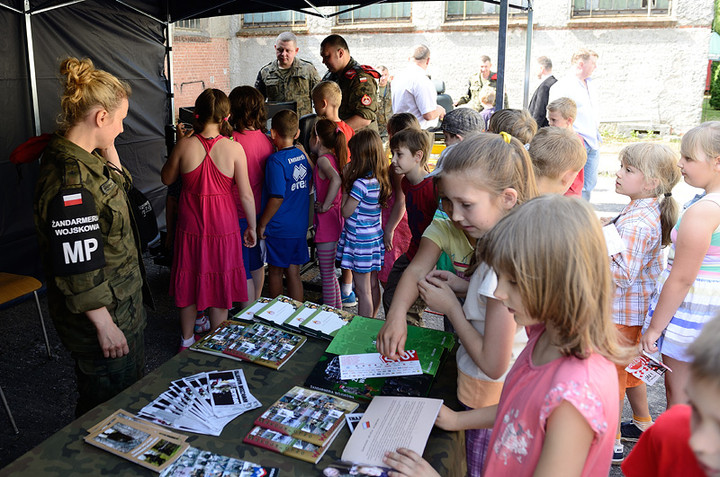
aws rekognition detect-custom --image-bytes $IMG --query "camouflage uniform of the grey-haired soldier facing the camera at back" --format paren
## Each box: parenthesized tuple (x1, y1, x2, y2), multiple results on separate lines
(255, 57, 320, 117)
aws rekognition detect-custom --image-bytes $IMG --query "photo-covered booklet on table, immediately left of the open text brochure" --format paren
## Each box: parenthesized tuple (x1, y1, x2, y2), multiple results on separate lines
(255, 386, 358, 446)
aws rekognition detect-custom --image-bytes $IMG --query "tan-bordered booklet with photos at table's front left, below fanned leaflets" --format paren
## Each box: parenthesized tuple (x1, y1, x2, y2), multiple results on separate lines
(84, 411, 190, 472)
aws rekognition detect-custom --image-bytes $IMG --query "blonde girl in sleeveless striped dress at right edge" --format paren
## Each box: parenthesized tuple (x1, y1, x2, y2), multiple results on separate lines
(640, 121, 720, 408)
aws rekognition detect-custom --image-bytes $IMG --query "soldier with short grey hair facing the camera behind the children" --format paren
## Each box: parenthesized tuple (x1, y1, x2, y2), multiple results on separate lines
(255, 31, 320, 117)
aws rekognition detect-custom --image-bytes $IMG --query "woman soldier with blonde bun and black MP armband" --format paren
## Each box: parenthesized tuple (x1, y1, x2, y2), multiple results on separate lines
(34, 58, 149, 416)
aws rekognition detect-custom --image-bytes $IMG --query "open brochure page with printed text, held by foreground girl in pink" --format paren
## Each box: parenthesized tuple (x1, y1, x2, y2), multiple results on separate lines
(342, 396, 442, 467)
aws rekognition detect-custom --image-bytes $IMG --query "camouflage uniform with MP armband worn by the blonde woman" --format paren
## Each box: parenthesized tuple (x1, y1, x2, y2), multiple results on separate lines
(34, 134, 151, 415)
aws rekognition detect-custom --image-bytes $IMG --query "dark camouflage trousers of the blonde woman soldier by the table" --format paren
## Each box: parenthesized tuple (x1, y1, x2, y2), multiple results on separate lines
(72, 330, 145, 417)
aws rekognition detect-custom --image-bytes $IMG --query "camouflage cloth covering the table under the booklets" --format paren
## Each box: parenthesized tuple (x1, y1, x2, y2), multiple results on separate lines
(0, 338, 466, 477)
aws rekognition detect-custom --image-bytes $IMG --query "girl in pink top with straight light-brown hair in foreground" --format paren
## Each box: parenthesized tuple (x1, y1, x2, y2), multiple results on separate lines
(385, 195, 633, 477)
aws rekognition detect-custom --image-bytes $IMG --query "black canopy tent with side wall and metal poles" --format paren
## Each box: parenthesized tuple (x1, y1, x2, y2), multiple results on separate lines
(0, 0, 532, 277)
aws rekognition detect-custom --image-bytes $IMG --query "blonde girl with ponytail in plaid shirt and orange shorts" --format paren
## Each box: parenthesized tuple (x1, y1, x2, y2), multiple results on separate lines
(604, 143, 680, 464)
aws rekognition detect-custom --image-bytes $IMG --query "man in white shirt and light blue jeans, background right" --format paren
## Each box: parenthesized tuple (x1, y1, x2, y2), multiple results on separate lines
(548, 48, 601, 200)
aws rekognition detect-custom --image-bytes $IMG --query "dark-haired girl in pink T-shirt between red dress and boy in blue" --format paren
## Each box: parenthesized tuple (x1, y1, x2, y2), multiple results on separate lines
(229, 86, 275, 306)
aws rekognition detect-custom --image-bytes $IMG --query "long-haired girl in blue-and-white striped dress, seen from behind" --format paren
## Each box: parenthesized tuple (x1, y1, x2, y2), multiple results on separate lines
(336, 129, 392, 318)
